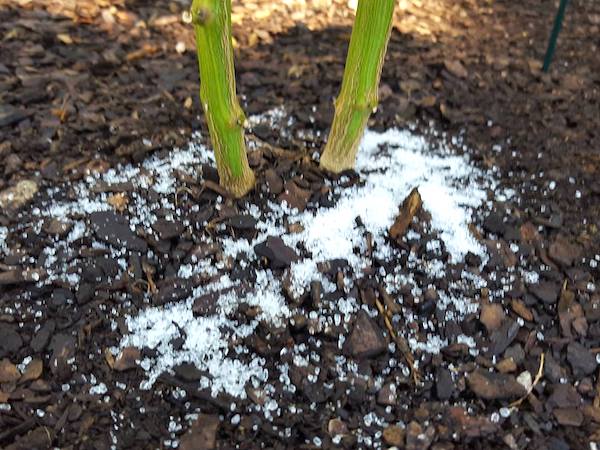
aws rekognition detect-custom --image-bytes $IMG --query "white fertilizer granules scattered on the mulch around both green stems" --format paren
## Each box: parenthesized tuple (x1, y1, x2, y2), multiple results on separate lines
(0, 111, 505, 400)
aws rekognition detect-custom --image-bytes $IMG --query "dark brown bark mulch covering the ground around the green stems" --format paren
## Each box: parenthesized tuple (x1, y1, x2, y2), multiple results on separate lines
(0, 0, 600, 450)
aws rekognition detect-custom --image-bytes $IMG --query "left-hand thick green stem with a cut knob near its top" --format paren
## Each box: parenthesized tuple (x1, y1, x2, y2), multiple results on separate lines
(191, 0, 254, 197)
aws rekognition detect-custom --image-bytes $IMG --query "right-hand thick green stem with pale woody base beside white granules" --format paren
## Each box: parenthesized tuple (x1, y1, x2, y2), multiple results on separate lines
(321, 0, 396, 173)
